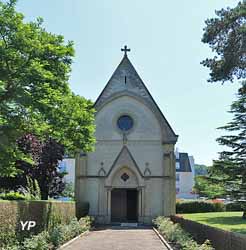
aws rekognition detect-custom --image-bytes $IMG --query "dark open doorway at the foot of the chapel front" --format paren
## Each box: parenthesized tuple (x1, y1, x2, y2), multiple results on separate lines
(111, 188, 138, 222)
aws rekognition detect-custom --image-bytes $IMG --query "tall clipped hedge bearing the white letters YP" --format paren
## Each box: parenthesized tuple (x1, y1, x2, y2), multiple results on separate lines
(0, 200, 88, 248)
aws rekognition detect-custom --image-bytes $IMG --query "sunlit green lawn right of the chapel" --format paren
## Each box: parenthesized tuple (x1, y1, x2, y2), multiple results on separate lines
(182, 212, 246, 234)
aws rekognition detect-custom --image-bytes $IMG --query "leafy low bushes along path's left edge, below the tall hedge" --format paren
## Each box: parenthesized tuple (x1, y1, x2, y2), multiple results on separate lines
(1, 216, 93, 250)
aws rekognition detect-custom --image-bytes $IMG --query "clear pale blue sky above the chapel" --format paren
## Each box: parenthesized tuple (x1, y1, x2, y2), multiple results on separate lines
(17, 0, 239, 165)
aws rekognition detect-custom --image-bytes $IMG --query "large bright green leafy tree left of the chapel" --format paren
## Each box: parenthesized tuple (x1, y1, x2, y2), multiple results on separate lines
(0, 0, 94, 176)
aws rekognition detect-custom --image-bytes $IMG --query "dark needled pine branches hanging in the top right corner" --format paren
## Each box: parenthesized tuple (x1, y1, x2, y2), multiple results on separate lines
(201, 0, 246, 82)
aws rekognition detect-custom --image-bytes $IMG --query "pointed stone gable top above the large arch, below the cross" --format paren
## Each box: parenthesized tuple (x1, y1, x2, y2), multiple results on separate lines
(94, 55, 178, 142)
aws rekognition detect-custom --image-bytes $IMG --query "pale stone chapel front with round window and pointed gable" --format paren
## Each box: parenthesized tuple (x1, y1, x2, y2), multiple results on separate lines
(75, 51, 177, 223)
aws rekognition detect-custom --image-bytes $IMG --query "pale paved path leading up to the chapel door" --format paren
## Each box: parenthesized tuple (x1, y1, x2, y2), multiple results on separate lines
(64, 228, 167, 250)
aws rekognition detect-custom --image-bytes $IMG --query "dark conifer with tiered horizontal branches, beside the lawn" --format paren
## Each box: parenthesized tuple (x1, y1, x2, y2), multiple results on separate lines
(210, 82, 246, 218)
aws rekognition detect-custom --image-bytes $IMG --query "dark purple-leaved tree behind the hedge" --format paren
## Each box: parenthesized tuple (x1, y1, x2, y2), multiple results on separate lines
(0, 134, 66, 200)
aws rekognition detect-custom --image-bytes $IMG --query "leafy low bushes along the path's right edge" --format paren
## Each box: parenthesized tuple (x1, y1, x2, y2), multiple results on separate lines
(153, 216, 214, 250)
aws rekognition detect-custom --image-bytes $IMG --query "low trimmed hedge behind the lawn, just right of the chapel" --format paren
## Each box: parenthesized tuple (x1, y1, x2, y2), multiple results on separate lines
(176, 200, 225, 214)
